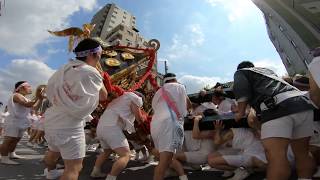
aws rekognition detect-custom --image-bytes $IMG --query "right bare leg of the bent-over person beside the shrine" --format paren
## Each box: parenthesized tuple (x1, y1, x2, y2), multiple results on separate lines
(109, 147, 130, 176)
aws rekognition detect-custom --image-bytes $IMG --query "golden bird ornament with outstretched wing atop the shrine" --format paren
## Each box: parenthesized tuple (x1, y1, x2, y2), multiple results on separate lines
(48, 24, 95, 52)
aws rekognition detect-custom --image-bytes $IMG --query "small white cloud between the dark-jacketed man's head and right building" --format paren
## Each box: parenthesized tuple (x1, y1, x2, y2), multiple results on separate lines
(253, 59, 287, 76)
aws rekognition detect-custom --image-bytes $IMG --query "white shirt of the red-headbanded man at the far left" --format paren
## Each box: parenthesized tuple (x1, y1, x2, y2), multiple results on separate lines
(5, 95, 30, 129)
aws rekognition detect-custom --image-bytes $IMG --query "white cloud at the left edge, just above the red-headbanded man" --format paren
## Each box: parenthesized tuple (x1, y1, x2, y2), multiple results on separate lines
(0, 59, 55, 104)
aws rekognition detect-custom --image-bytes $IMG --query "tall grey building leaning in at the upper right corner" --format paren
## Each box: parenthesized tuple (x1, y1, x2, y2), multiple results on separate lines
(252, 0, 320, 75)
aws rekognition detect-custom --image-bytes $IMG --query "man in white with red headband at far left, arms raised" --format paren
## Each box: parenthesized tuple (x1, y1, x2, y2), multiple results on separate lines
(0, 81, 42, 165)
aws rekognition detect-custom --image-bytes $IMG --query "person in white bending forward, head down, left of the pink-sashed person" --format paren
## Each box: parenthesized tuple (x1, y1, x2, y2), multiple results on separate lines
(91, 92, 143, 180)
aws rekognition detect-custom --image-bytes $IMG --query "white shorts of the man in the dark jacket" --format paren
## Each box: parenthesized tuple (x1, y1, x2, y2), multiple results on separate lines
(261, 110, 313, 139)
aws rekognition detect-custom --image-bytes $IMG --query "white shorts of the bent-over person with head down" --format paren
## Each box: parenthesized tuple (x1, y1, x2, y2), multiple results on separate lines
(97, 125, 129, 150)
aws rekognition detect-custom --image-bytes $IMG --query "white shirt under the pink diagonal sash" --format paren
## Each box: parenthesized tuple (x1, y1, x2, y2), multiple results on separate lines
(152, 83, 188, 121)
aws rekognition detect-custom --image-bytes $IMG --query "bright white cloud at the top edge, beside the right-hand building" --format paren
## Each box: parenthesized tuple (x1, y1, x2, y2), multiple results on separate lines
(205, 0, 255, 22)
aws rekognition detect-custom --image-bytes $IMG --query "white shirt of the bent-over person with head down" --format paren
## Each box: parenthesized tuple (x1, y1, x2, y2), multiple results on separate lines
(99, 92, 143, 132)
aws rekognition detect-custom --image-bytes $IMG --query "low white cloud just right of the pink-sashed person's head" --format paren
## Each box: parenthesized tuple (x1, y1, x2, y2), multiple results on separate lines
(178, 75, 226, 94)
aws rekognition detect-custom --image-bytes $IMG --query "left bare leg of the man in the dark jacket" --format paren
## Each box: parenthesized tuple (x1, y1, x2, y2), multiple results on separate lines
(262, 138, 291, 180)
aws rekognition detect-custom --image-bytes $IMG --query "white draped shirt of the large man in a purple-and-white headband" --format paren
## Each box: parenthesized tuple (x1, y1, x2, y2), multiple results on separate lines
(45, 60, 102, 129)
